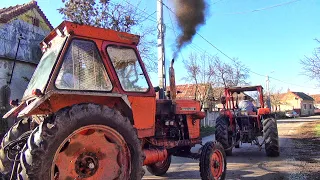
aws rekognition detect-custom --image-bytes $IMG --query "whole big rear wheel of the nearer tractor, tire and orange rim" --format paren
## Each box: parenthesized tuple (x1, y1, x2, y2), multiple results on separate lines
(18, 104, 143, 180)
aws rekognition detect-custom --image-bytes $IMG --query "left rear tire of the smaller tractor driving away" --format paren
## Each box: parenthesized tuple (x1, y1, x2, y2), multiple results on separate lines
(215, 116, 232, 156)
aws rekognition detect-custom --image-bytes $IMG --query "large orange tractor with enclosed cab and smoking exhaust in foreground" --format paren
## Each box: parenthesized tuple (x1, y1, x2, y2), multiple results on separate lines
(0, 21, 226, 180)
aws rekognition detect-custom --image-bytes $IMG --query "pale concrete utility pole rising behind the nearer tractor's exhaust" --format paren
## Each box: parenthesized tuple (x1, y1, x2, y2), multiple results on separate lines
(157, 0, 166, 99)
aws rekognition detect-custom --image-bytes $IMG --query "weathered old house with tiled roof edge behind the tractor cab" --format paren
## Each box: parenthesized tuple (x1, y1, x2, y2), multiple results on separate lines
(0, 1, 53, 108)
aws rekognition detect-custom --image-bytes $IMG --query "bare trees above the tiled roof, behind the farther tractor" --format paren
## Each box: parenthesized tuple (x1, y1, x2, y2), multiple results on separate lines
(184, 53, 249, 105)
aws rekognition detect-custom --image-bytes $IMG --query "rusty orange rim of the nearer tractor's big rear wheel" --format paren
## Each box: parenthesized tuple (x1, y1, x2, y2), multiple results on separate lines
(51, 125, 131, 180)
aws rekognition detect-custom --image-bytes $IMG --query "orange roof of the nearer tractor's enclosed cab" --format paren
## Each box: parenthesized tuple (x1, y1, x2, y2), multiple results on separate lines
(42, 21, 140, 45)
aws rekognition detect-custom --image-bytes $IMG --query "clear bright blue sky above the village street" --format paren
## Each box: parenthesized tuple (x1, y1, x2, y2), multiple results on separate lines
(0, 0, 320, 94)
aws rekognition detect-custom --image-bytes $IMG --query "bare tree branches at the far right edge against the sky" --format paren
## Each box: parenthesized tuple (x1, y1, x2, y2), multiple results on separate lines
(300, 39, 320, 82)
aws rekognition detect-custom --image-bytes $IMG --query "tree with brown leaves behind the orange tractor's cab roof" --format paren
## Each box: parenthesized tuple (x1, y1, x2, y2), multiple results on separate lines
(58, 0, 157, 71)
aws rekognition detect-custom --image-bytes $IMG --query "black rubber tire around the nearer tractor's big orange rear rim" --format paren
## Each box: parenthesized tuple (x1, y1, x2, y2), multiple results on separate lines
(18, 104, 144, 180)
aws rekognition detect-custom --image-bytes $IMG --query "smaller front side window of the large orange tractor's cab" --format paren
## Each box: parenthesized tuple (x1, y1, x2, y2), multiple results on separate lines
(107, 46, 149, 92)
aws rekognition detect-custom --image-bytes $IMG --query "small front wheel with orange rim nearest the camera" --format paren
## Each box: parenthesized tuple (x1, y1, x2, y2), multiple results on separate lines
(199, 142, 227, 180)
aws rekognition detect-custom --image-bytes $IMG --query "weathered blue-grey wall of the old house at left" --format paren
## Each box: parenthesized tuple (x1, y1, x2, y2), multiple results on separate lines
(0, 8, 50, 107)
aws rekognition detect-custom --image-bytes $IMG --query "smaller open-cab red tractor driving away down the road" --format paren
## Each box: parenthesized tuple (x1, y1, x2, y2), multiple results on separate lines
(215, 86, 279, 156)
